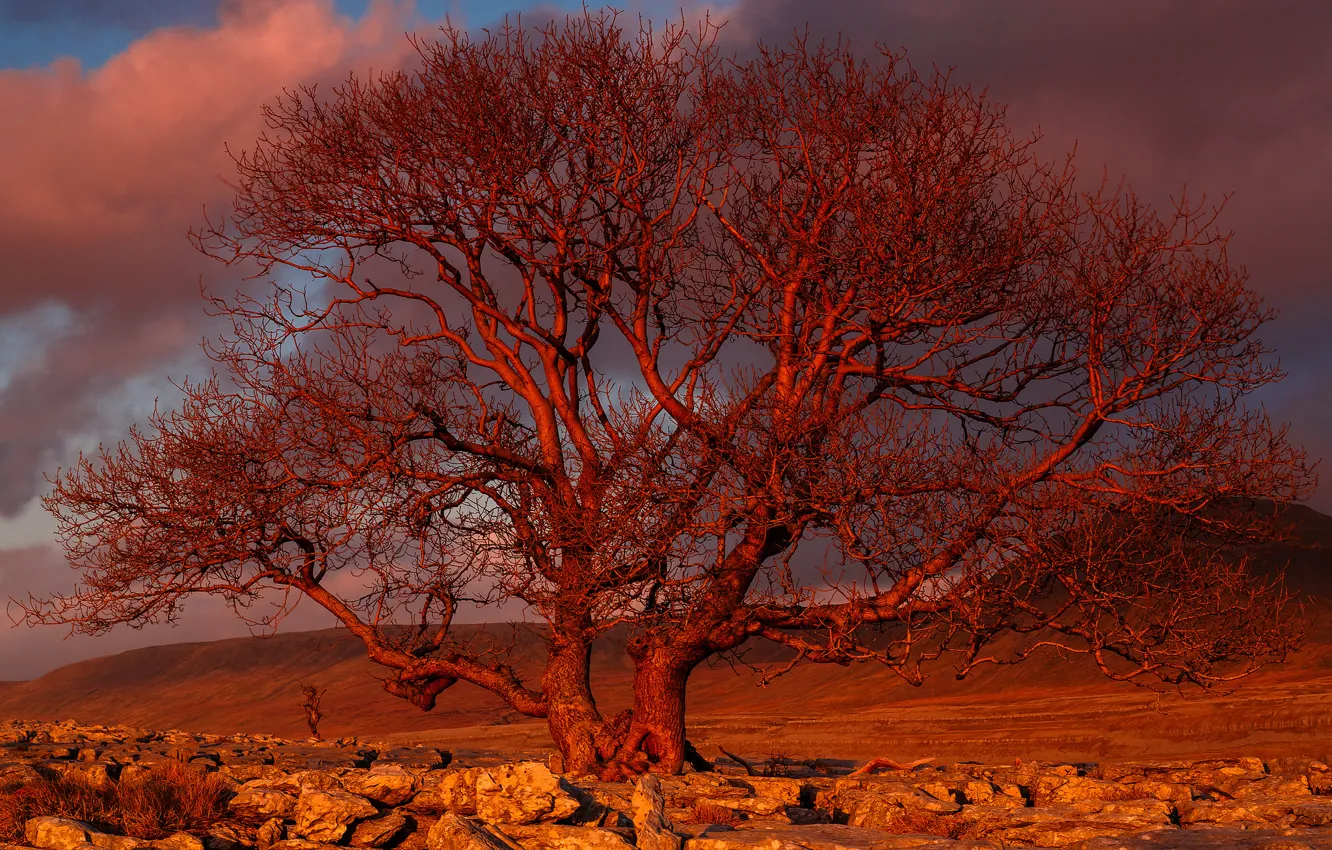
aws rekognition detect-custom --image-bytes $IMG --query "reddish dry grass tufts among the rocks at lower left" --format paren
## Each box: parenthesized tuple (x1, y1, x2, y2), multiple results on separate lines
(0, 762, 230, 843)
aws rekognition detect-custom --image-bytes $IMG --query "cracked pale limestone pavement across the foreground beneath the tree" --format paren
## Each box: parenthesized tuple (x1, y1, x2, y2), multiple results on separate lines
(0, 722, 1332, 850)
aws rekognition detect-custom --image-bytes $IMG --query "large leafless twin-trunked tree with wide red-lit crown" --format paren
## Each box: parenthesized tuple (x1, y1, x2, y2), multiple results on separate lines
(25, 9, 1312, 775)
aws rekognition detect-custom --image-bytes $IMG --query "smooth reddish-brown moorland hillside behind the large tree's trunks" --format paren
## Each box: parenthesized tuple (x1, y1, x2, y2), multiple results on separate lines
(0, 509, 1332, 761)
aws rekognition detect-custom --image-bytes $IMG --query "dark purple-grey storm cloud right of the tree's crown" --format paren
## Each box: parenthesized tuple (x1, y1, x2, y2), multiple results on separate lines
(723, 0, 1332, 510)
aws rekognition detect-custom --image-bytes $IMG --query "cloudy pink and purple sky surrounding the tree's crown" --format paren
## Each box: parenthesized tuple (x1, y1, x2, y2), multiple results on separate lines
(0, 0, 1332, 679)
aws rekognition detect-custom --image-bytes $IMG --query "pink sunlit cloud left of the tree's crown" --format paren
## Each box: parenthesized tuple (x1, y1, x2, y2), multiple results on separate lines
(0, 0, 410, 514)
